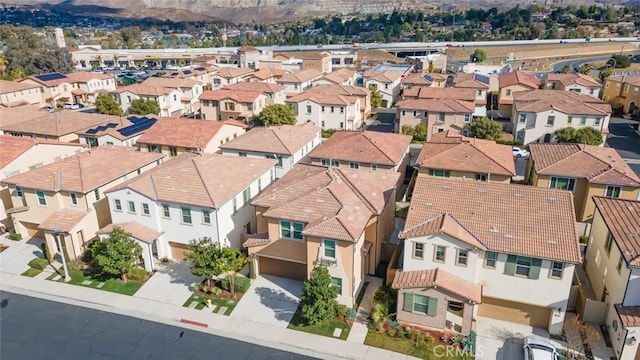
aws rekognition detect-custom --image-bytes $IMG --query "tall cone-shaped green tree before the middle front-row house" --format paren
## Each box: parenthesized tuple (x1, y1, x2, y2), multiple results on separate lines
(300, 265, 338, 325)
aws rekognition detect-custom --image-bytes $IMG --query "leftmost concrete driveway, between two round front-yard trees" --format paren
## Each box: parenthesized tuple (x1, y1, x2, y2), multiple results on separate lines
(133, 261, 202, 306)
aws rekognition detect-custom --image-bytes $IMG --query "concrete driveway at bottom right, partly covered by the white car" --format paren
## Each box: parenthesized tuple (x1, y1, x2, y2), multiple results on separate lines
(476, 317, 549, 360)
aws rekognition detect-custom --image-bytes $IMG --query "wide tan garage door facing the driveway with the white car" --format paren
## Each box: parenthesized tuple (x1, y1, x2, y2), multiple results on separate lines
(478, 297, 551, 329)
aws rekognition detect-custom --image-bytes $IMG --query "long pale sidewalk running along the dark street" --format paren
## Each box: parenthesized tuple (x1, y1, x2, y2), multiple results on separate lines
(0, 269, 415, 360)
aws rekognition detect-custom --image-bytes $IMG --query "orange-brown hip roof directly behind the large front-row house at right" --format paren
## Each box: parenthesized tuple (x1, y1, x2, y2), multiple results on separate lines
(416, 132, 516, 176)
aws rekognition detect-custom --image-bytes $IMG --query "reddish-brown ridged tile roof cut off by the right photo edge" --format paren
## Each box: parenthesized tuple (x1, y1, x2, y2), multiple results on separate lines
(592, 196, 640, 268)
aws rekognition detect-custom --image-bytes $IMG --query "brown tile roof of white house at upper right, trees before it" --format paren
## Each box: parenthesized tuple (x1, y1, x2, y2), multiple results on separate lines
(513, 89, 611, 116)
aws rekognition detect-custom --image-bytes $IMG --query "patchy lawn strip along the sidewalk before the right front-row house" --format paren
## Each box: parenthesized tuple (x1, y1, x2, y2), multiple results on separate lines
(364, 330, 474, 360)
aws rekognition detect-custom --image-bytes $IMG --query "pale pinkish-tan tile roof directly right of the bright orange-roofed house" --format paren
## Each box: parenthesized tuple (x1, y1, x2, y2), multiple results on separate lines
(220, 122, 321, 155)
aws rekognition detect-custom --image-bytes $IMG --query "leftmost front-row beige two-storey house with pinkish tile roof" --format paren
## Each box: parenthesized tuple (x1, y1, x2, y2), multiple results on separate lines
(2, 146, 164, 259)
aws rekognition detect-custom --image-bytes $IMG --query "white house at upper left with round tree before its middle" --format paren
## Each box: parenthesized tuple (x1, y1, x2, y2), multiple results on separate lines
(111, 84, 184, 117)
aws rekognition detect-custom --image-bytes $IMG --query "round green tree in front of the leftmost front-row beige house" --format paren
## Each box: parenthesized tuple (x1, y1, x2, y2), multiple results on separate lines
(90, 227, 142, 282)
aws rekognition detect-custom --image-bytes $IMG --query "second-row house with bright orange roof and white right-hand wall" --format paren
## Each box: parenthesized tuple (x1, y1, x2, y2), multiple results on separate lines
(137, 118, 247, 157)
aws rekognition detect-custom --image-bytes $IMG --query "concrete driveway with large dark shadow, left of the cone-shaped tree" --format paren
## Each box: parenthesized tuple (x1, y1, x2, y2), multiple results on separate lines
(231, 275, 303, 328)
